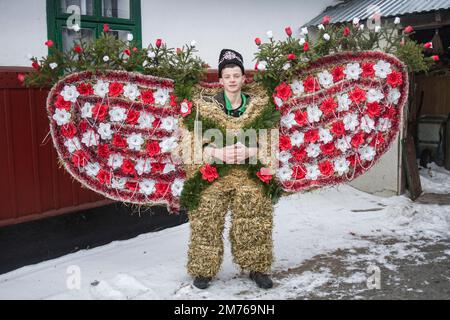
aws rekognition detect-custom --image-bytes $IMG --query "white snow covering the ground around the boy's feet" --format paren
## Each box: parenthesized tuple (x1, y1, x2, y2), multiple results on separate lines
(0, 166, 450, 299)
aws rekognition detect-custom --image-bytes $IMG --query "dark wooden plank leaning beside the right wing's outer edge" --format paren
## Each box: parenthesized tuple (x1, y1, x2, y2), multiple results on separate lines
(402, 135, 422, 200)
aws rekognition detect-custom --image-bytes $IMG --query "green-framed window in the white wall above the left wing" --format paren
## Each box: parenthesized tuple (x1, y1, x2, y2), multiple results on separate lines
(47, 0, 142, 51)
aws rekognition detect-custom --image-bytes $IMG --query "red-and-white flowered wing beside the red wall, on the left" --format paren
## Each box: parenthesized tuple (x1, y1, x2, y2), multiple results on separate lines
(47, 71, 185, 212)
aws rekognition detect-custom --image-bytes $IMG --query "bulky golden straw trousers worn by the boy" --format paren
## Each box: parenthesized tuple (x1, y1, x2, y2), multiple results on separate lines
(187, 168, 273, 277)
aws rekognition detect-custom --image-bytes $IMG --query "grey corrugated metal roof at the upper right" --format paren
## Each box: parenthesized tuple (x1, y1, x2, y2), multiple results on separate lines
(305, 0, 450, 26)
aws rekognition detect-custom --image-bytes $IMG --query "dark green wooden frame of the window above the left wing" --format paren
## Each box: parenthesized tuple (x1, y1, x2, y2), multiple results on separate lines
(47, 0, 142, 54)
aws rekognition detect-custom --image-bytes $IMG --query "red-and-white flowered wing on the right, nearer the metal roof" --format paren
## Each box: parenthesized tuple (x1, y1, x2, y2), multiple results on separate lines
(274, 51, 408, 192)
